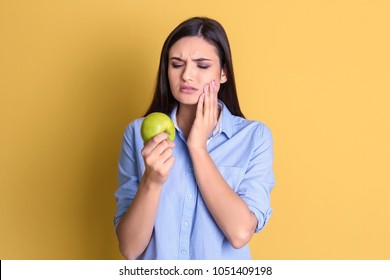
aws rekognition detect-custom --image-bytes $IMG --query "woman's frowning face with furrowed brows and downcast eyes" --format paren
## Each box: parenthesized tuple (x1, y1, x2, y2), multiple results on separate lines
(168, 37, 227, 105)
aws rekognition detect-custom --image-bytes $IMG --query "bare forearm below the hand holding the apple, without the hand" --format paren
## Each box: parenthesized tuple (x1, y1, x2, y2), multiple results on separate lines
(117, 178, 161, 259)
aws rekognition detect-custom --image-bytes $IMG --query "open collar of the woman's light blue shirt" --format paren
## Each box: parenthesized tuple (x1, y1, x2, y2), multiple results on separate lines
(170, 100, 233, 144)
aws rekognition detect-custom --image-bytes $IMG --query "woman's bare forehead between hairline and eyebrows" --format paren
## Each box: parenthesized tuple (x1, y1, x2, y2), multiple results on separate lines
(169, 36, 218, 59)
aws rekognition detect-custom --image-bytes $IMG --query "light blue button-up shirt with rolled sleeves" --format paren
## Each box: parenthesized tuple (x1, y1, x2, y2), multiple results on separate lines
(114, 102, 275, 260)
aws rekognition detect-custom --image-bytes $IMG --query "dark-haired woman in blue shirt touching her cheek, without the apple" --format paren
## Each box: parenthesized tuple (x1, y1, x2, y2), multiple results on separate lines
(114, 17, 274, 259)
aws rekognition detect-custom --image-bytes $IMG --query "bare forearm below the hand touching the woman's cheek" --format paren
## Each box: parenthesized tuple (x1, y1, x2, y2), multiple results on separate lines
(190, 148, 257, 248)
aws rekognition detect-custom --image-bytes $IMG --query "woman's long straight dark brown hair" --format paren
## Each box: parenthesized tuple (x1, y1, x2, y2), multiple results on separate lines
(145, 17, 244, 118)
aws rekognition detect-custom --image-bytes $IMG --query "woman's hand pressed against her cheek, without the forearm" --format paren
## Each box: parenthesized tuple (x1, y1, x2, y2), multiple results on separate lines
(187, 81, 219, 152)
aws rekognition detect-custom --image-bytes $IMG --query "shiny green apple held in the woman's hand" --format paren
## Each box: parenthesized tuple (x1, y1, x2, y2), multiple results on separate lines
(141, 112, 176, 143)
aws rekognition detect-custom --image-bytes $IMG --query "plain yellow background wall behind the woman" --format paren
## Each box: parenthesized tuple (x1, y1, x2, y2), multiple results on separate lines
(0, 0, 390, 259)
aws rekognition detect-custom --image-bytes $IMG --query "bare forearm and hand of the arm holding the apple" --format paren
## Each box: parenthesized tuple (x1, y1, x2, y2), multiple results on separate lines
(117, 133, 175, 259)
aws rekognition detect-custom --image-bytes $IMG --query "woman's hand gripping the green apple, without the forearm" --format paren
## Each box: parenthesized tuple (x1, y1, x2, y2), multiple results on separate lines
(141, 133, 175, 186)
